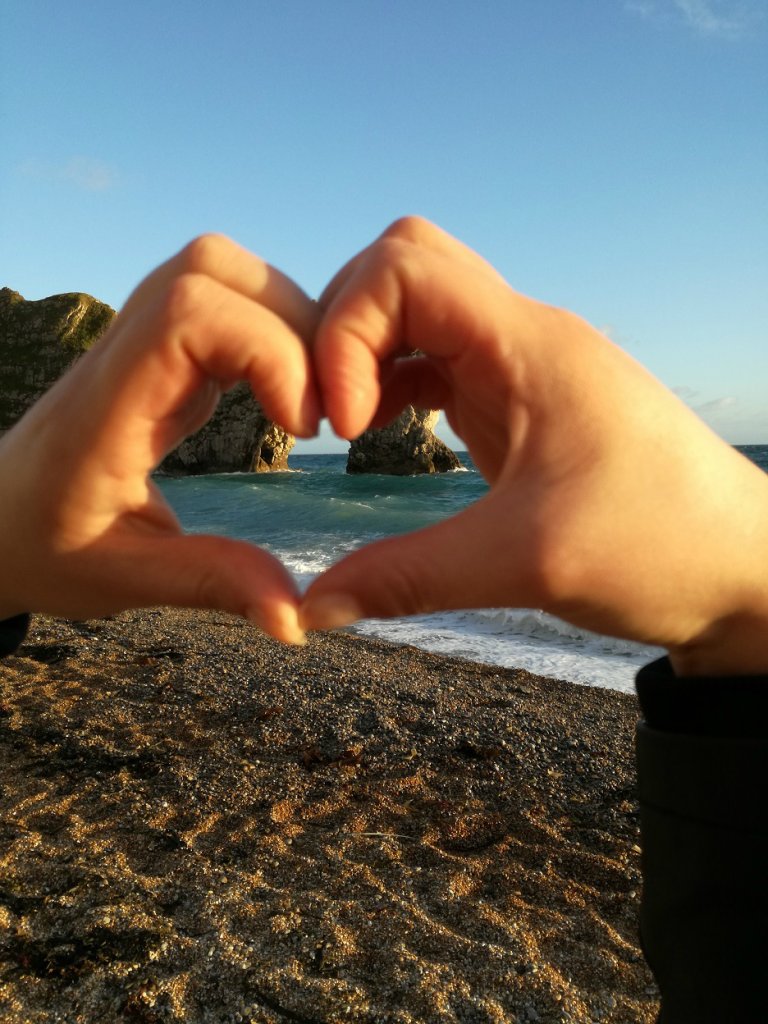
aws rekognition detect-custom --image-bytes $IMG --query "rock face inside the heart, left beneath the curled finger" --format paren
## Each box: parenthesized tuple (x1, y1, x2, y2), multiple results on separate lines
(160, 382, 296, 476)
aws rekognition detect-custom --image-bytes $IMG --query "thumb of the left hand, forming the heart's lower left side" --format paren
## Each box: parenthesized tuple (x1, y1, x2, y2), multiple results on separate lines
(115, 535, 304, 643)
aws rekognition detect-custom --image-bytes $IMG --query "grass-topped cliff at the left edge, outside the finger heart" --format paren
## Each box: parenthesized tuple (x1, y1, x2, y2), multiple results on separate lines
(0, 288, 115, 433)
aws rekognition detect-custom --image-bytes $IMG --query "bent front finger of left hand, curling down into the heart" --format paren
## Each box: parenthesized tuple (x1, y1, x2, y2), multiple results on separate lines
(81, 274, 319, 468)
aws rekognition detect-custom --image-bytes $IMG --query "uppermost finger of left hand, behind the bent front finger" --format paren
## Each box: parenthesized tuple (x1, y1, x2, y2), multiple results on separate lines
(124, 234, 319, 342)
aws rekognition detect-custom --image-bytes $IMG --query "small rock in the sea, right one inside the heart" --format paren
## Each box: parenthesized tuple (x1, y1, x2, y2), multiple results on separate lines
(347, 406, 461, 476)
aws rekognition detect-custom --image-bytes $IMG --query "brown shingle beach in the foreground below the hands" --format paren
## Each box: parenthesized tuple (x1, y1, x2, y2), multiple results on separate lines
(0, 609, 657, 1024)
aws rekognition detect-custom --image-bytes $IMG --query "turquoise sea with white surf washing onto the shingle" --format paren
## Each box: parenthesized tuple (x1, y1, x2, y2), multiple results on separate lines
(157, 444, 768, 692)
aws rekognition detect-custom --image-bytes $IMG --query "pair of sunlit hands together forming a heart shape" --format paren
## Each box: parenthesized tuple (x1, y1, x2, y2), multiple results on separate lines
(0, 218, 768, 675)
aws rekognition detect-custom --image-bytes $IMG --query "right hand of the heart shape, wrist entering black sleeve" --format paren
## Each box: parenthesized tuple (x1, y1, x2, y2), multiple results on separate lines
(301, 218, 768, 674)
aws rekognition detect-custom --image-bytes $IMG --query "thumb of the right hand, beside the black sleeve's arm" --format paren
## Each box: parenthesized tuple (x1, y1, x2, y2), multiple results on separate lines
(299, 498, 528, 630)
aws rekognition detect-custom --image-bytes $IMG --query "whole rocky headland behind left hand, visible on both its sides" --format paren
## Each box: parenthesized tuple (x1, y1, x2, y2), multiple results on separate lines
(0, 288, 295, 475)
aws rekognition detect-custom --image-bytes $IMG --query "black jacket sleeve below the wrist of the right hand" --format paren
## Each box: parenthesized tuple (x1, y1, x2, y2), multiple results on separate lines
(637, 658, 768, 1024)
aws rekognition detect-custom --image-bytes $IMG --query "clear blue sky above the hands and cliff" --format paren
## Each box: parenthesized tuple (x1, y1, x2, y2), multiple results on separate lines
(0, 0, 768, 449)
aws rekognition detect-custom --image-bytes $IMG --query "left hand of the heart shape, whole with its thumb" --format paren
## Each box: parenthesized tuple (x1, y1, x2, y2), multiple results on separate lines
(0, 236, 319, 641)
